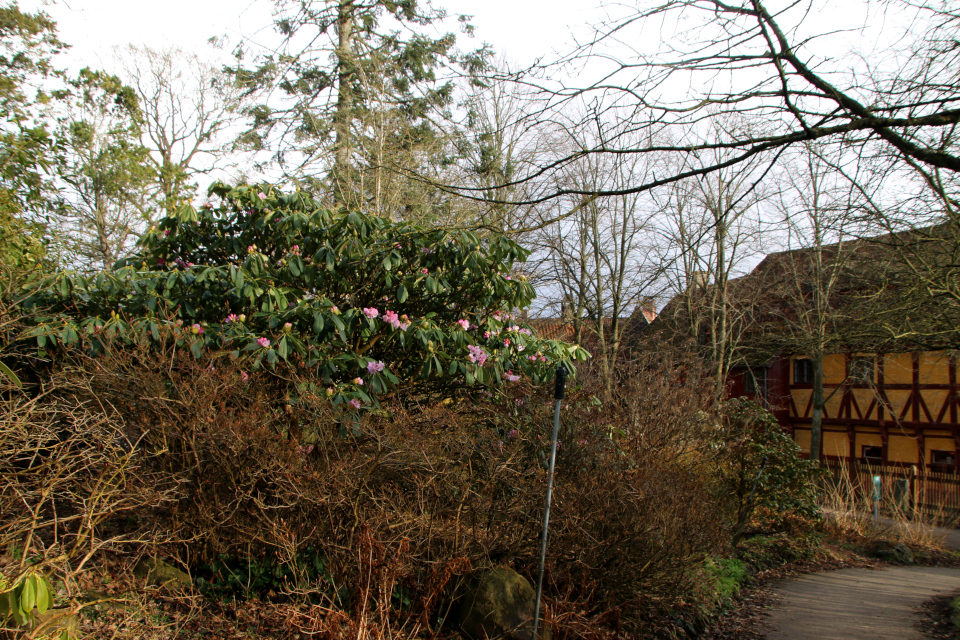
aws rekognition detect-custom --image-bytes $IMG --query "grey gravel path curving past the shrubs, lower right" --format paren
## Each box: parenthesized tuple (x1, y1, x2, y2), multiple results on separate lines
(766, 567, 960, 640)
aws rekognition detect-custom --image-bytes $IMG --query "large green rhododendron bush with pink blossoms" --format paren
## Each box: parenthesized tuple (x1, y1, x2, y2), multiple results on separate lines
(27, 184, 587, 408)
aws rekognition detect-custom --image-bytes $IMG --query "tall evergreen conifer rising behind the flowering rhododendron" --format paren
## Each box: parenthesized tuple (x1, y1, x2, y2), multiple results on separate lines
(234, 0, 487, 217)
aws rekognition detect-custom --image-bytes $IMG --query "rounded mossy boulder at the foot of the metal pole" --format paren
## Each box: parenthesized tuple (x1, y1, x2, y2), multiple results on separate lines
(457, 567, 547, 640)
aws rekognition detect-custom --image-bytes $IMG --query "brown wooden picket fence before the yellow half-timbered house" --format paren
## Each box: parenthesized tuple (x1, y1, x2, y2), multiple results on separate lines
(822, 460, 960, 521)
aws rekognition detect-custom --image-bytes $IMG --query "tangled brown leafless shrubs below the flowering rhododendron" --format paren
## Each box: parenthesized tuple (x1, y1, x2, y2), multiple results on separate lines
(0, 330, 796, 640)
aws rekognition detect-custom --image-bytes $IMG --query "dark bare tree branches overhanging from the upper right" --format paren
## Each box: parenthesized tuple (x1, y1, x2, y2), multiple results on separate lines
(436, 0, 960, 221)
